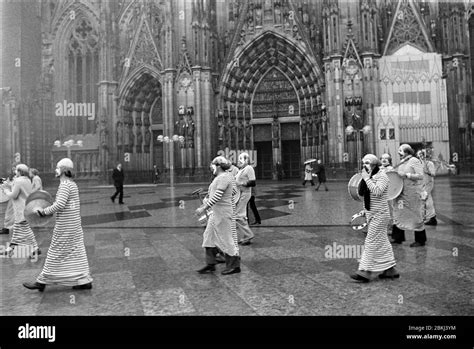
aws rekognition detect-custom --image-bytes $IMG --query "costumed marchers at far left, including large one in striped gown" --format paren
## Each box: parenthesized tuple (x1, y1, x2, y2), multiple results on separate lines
(2, 158, 92, 291)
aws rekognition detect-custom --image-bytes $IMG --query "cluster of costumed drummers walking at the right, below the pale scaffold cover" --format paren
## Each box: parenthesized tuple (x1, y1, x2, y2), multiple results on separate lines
(351, 144, 436, 282)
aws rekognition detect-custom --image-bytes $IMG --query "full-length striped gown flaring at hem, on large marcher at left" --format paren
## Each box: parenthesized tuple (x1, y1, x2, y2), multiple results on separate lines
(37, 179, 92, 286)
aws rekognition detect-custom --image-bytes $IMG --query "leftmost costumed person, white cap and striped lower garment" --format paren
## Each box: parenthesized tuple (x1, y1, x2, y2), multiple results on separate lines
(2, 164, 41, 258)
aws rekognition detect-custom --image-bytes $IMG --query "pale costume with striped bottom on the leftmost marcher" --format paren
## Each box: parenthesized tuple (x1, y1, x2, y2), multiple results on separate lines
(5, 176, 38, 249)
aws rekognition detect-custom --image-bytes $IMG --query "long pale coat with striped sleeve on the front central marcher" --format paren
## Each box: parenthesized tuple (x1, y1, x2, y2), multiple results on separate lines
(202, 172, 239, 256)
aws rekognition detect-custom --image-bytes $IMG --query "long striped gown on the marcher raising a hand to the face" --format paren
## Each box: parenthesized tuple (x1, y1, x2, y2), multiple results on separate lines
(359, 171, 396, 272)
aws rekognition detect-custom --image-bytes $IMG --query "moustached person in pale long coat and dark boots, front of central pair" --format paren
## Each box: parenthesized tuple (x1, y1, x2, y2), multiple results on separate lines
(196, 156, 240, 275)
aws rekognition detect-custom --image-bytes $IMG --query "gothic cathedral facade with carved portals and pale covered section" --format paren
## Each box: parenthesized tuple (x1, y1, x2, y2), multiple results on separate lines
(0, 0, 474, 181)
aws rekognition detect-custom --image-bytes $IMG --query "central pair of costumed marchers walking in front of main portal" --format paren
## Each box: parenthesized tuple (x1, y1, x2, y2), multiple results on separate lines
(196, 153, 256, 275)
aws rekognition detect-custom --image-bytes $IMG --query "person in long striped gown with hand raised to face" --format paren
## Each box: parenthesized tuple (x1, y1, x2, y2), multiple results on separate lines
(351, 154, 399, 282)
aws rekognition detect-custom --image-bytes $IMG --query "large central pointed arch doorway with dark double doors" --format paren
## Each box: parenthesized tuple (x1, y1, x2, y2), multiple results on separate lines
(218, 31, 326, 179)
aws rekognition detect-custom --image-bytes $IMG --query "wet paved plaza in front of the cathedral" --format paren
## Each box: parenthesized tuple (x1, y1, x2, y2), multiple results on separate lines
(0, 176, 474, 316)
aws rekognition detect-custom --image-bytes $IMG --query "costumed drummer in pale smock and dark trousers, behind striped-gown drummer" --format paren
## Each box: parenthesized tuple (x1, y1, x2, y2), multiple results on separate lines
(391, 144, 426, 247)
